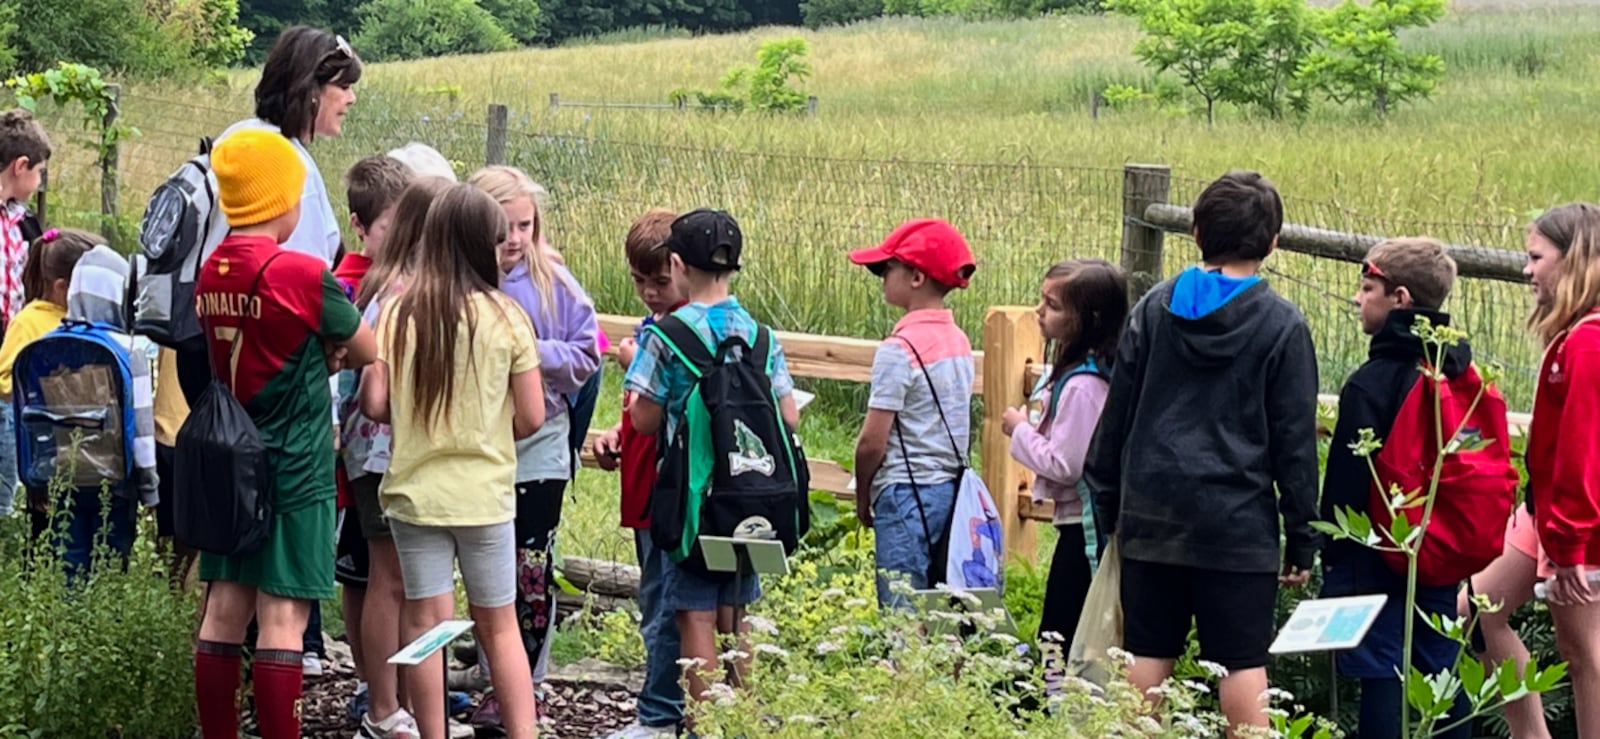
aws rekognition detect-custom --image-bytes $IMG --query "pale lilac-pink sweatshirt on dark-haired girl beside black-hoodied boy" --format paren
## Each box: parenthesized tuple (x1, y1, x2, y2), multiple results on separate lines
(1011, 374, 1110, 525)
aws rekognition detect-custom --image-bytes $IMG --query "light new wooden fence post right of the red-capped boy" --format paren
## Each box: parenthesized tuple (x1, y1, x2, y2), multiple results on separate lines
(982, 306, 1045, 561)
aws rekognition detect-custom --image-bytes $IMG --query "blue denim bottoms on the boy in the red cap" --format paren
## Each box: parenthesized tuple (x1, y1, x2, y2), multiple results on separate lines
(872, 480, 955, 609)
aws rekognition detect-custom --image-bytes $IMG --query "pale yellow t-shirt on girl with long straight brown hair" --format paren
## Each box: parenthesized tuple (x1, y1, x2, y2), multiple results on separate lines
(378, 293, 539, 526)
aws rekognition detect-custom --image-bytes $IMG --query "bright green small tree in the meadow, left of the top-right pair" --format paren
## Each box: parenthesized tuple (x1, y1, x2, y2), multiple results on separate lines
(1109, 0, 1317, 123)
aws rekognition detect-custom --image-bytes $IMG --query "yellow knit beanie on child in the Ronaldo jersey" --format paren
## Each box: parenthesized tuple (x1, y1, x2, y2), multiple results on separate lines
(211, 128, 306, 227)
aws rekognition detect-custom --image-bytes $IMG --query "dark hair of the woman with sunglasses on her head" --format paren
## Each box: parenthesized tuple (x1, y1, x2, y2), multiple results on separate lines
(256, 26, 362, 142)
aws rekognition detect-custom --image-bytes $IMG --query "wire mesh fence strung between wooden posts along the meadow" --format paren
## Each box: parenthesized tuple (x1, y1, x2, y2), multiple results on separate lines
(34, 94, 1538, 408)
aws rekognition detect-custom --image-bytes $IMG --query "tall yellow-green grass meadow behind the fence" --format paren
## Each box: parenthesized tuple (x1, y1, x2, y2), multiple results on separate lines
(28, 5, 1600, 569)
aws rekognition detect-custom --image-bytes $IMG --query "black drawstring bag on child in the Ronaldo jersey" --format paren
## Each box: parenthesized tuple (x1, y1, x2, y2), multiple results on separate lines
(173, 253, 283, 557)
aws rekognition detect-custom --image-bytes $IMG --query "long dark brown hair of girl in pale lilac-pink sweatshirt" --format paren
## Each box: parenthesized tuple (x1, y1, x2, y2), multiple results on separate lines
(1045, 259, 1128, 387)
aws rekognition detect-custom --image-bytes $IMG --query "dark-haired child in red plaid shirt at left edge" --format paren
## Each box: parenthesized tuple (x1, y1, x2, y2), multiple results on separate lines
(0, 110, 50, 515)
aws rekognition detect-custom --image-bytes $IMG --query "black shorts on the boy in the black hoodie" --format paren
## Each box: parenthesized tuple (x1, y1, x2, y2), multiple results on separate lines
(1122, 560, 1278, 670)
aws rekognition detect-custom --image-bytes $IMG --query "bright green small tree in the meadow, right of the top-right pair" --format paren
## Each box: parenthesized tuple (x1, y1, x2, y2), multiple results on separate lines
(1298, 0, 1445, 115)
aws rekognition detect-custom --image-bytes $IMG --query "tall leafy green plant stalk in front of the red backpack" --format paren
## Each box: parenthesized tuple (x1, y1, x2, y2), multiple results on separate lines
(1314, 317, 1566, 739)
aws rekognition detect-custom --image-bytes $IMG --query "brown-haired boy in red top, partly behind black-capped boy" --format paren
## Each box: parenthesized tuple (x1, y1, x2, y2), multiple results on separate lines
(595, 208, 685, 739)
